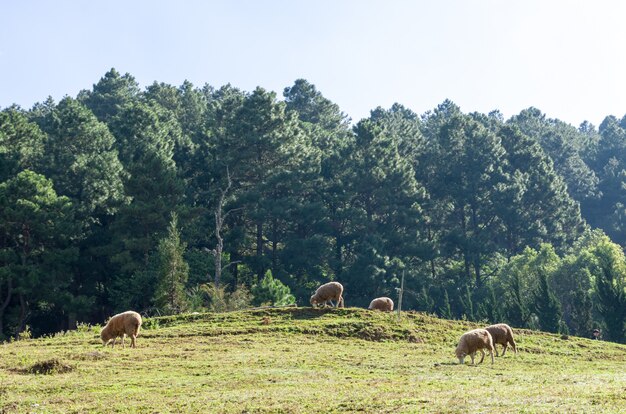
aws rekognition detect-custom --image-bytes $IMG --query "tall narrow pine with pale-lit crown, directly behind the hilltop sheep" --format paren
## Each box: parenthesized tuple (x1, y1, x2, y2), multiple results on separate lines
(281, 79, 353, 286)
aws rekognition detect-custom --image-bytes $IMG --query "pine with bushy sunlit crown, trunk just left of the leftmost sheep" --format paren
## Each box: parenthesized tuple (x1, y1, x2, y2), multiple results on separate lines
(32, 98, 129, 326)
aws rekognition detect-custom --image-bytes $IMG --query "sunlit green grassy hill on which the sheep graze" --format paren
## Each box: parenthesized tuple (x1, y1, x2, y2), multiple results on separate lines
(0, 308, 626, 413)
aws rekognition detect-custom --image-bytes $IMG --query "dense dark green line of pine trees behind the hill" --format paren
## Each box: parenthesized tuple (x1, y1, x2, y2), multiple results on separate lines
(0, 69, 626, 342)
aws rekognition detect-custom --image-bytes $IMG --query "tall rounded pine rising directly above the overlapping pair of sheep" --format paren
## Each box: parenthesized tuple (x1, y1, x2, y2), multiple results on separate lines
(416, 101, 506, 289)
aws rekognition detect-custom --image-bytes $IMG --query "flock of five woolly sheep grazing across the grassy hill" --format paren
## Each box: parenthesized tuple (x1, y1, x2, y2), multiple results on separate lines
(100, 282, 517, 365)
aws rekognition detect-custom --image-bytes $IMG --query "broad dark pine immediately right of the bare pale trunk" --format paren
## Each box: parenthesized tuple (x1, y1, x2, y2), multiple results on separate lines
(211, 88, 319, 284)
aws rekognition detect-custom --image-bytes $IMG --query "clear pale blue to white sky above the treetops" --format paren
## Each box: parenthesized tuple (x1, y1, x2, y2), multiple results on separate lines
(0, 0, 626, 126)
